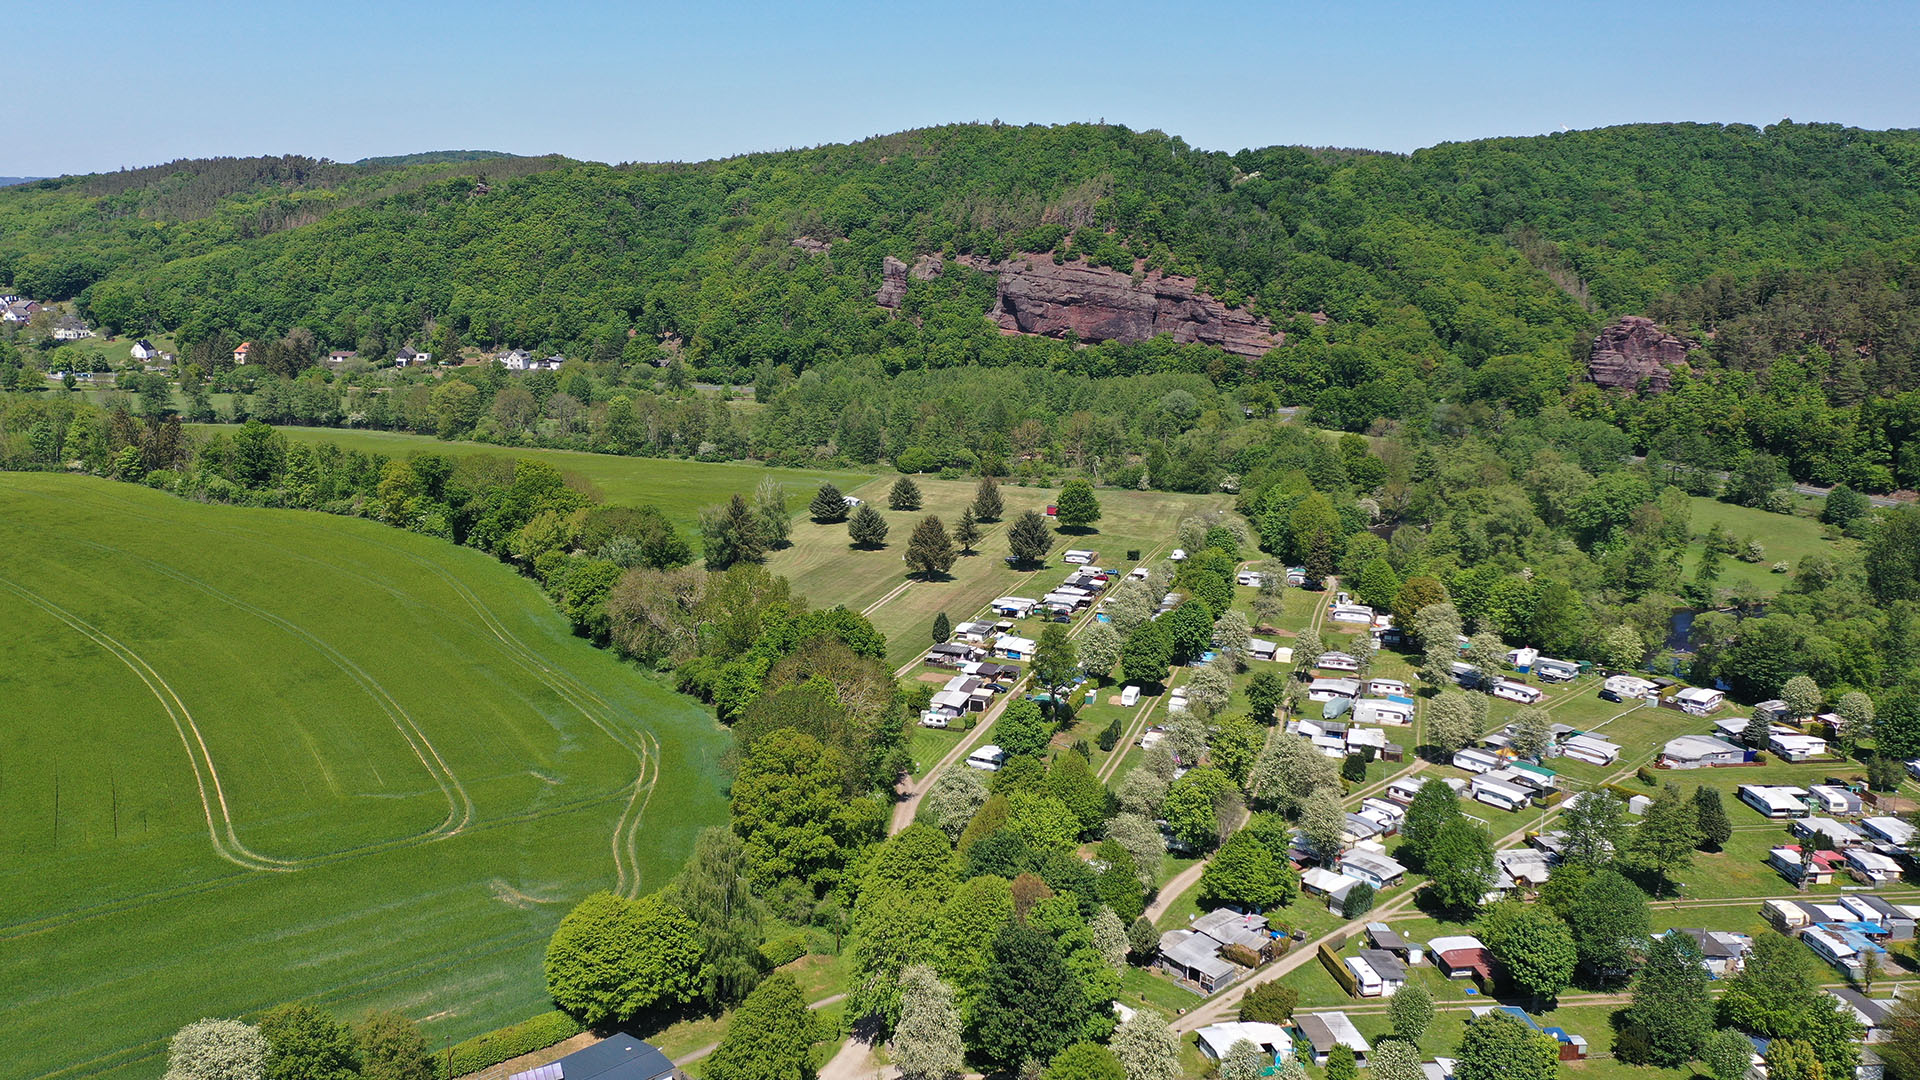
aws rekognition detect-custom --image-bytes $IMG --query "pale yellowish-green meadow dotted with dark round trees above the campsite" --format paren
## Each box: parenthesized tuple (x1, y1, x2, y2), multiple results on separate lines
(766, 473, 1229, 665)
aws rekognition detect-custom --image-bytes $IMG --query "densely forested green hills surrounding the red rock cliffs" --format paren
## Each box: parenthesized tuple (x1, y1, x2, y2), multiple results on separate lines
(11, 121, 1920, 486)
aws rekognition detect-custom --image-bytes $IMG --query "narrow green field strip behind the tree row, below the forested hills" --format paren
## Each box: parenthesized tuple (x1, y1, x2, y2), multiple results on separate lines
(192, 425, 867, 530)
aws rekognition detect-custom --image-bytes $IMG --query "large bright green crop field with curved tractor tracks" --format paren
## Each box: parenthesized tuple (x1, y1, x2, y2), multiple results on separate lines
(0, 474, 726, 1080)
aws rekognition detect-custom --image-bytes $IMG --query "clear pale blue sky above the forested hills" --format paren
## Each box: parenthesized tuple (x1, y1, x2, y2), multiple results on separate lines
(0, 0, 1920, 175)
